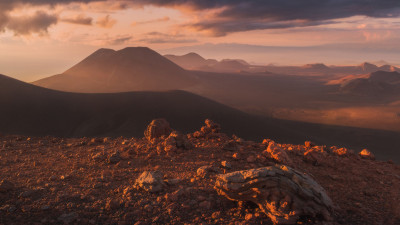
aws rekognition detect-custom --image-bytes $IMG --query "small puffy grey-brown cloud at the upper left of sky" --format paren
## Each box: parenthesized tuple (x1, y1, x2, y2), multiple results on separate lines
(5, 11, 58, 36)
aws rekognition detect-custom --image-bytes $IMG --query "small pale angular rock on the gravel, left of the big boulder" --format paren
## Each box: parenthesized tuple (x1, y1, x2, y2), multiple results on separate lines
(136, 171, 166, 192)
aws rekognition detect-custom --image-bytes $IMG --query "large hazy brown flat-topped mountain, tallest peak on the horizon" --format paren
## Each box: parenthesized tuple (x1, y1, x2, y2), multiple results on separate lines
(33, 47, 196, 93)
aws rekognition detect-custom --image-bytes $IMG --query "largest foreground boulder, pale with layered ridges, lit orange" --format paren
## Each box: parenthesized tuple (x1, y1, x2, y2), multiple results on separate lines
(215, 166, 333, 224)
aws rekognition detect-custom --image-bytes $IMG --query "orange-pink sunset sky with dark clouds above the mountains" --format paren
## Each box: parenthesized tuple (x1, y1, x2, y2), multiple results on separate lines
(0, 0, 400, 81)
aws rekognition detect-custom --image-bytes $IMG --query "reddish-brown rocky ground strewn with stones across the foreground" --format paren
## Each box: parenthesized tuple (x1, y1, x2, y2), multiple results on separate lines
(0, 120, 400, 225)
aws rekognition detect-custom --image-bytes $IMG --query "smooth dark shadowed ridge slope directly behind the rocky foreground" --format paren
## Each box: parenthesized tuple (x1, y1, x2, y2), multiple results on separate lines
(0, 75, 400, 162)
